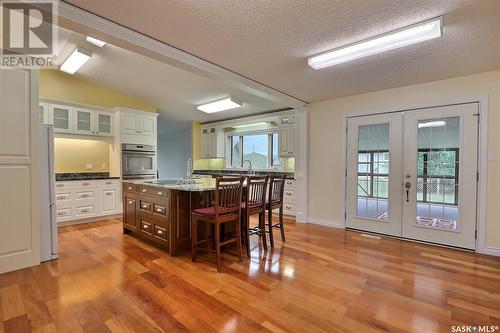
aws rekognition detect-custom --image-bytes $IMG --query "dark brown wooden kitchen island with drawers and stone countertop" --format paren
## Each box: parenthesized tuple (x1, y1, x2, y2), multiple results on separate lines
(123, 179, 215, 256)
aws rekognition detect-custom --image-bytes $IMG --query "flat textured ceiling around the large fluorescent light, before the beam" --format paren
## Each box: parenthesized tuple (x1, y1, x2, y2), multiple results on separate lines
(65, 0, 500, 102)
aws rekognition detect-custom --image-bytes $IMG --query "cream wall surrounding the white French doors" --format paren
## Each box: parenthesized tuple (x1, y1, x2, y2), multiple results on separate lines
(308, 71, 500, 248)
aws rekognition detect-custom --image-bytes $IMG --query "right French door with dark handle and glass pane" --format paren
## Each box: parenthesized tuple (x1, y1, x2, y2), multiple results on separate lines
(403, 104, 478, 249)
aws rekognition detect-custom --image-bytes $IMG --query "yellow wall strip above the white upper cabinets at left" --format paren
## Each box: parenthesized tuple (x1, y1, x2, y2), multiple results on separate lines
(40, 69, 156, 112)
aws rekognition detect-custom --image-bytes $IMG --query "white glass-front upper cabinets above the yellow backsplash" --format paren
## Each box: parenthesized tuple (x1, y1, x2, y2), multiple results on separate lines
(40, 103, 114, 136)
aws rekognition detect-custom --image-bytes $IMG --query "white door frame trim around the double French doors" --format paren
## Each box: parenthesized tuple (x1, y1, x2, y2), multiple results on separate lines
(342, 95, 488, 256)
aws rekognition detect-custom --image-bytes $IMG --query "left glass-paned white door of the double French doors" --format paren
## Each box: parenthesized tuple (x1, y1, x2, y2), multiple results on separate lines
(346, 114, 403, 236)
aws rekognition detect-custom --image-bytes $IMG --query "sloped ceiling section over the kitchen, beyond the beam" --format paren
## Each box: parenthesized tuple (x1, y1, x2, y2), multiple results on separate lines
(56, 28, 285, 132)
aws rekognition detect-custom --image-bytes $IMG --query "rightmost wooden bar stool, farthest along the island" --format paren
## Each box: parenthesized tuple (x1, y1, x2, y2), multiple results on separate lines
(266, 176, 285, 247)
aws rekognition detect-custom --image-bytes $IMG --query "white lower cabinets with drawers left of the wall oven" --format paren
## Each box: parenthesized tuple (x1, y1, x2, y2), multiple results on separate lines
(55, 179, 122, 225)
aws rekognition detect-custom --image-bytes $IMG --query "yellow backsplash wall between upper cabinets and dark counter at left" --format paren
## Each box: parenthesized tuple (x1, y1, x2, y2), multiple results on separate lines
(54, 138, 109, 173)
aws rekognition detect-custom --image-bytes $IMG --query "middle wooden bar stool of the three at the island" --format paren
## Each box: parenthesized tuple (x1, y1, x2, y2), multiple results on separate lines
(241, 176, 269, 258)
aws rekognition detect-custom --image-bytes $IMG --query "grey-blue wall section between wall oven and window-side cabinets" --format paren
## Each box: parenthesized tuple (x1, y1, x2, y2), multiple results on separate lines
(158, 127, 192, 179)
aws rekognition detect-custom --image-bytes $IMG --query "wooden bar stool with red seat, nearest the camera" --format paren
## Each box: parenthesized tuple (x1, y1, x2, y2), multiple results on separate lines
(191, 177, 244, 273)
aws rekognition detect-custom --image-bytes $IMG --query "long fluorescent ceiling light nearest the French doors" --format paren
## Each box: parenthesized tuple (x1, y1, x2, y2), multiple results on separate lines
(307, 16, 443, 69)
